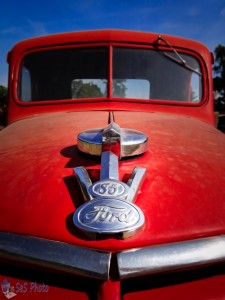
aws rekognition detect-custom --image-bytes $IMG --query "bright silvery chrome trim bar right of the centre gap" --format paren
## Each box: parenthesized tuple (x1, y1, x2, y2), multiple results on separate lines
(117, 236, 225, 279)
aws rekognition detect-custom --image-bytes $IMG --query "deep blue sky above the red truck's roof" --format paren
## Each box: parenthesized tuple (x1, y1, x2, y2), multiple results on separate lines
(0, 0, 225, 86)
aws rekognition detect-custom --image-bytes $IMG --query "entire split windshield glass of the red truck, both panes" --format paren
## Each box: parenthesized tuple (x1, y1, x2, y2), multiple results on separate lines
(19, 47, 202, 103)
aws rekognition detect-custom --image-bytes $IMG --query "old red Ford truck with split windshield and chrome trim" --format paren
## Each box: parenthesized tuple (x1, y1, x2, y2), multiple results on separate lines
(0, 30, 225, 300)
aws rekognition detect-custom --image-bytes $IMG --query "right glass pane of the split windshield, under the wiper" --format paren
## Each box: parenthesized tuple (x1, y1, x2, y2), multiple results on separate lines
(113, 48, 202, 102)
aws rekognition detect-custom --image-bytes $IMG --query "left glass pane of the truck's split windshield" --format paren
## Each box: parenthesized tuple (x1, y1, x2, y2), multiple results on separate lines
(19, 47, 108, 101)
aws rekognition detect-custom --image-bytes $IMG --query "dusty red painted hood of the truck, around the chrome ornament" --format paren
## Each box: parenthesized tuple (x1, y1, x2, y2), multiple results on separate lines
(0, 112, 225, 251)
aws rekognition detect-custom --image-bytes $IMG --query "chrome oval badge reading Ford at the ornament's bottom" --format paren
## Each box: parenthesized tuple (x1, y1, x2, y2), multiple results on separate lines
(73, 199, 144, 234)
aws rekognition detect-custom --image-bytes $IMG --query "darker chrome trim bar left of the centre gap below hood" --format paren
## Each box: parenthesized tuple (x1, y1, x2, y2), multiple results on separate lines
(0, 232, 111, 280)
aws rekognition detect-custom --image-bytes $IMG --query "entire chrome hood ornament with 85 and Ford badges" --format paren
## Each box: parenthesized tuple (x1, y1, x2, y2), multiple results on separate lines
(73, 113, 148, 238)
